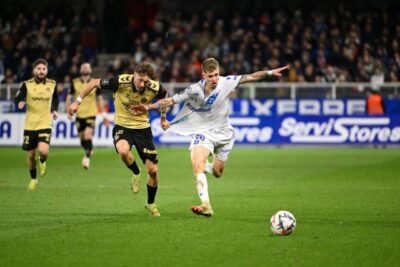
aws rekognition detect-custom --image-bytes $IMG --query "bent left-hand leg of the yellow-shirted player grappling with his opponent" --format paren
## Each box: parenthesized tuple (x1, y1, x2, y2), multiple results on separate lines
(116, 139, 140, 194)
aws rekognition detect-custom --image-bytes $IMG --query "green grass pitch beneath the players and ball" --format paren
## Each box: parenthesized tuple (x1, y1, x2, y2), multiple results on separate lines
(0, 147, 400, 267)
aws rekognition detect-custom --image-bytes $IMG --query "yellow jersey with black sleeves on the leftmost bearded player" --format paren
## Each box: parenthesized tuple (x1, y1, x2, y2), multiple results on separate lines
(14, 78, 58, 130)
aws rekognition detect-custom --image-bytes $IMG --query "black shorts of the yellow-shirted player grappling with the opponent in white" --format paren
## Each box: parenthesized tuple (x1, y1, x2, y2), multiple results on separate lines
(113, 125, 158, 163)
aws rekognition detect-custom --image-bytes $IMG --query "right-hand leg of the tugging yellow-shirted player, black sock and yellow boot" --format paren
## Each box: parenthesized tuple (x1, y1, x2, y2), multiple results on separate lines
(144, 160, 160, 216)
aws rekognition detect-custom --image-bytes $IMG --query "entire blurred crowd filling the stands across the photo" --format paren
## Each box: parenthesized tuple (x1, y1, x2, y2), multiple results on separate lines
(0, 0, 400, 89)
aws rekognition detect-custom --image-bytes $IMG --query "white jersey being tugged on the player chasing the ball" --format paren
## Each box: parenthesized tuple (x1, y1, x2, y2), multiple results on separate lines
(171, 75, 242, 135)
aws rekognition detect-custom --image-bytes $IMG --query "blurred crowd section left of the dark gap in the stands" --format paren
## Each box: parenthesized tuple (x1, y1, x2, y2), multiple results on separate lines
(0, 1, 98, 84)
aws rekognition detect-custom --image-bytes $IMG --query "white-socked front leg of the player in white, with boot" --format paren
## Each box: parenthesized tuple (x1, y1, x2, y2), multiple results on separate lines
(191, 146, 214, 217)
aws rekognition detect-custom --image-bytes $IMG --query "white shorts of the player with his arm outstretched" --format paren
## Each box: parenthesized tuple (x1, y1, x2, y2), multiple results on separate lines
(189, 128, 235, 161)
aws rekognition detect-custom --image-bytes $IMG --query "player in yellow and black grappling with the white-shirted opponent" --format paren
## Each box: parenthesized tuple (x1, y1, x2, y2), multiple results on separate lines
(68, 62, 167, 216)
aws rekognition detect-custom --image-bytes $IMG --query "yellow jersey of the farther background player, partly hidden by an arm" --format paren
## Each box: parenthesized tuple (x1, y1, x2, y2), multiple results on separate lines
(69, 78, 101, 118)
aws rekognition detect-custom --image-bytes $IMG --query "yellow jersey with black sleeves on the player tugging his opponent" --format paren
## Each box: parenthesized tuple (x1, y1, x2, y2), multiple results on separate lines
(100, 74, 167, 129)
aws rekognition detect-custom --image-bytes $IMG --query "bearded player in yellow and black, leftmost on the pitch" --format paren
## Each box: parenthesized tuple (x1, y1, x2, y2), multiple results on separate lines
(14, 59, 58, 191)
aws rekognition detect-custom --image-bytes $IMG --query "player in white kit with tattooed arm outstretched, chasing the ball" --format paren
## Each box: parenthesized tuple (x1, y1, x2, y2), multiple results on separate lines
(142, 58, 289, 217)
